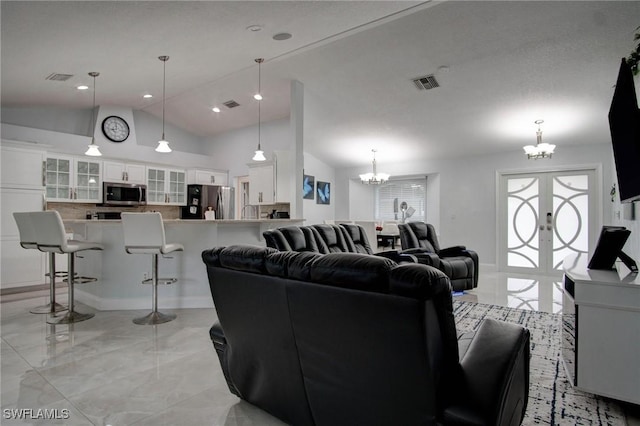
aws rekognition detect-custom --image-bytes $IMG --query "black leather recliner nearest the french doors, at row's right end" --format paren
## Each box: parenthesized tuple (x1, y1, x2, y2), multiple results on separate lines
(398, 222, 478, 291)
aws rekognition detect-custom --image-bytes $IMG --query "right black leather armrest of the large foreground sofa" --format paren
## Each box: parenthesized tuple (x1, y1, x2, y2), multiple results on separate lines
(443, 319, 530, 425)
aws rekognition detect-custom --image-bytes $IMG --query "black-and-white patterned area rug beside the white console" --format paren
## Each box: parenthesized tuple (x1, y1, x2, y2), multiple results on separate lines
(453, 300, 627, 426)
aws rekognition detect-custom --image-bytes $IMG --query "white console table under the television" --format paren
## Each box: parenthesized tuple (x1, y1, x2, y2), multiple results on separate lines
(562, 254, 640, 404)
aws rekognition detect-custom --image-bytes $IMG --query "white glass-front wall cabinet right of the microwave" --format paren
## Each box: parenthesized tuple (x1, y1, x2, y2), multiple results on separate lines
(147, 167, 187, 206)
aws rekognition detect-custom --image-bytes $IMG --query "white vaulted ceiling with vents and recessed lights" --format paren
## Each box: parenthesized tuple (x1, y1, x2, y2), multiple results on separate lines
(1, 1, 640, 167)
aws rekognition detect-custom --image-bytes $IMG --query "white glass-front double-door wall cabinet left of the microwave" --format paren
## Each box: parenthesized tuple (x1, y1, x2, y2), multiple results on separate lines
(45, 154, 102, 203)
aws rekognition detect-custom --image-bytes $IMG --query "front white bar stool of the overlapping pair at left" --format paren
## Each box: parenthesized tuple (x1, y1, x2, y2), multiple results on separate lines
(32, 210, 102, 324)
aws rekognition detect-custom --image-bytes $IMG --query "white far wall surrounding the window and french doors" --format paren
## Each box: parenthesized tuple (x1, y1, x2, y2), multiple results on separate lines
(336, 144, 613, 265)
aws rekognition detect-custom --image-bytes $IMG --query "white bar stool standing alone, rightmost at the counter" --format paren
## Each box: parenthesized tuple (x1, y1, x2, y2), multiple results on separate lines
(121, 212, 184, 324)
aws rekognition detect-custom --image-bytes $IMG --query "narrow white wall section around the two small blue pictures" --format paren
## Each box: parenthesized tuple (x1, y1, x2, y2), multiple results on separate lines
(304, 153, 344, 225)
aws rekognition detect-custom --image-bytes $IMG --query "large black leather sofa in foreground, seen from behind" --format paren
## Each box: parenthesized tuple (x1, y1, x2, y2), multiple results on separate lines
(202, 246, 530, 426)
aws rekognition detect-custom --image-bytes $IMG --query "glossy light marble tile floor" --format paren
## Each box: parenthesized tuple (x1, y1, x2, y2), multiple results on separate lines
(0, 273, 640, 426)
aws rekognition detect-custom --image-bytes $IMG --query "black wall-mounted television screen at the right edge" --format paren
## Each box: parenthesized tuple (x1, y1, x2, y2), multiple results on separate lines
(609, 58, 640, 203)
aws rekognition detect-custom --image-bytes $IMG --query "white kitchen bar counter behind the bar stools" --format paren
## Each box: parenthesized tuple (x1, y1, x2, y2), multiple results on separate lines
(64, 219, 304, 311)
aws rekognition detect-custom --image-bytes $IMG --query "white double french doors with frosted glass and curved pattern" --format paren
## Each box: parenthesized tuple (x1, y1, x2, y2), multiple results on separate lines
(498, 169, 599, 274)
